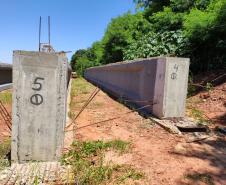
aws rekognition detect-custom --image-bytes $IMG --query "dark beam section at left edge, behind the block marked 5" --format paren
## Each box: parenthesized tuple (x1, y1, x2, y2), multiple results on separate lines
(0, 63, 12, 85)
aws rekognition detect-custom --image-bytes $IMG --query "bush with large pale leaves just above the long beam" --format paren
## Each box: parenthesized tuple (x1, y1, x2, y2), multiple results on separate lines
(124, 31, 186, 60)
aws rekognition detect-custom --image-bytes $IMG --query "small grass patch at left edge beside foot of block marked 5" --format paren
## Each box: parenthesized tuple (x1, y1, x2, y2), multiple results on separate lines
(0, 139, 11, 170)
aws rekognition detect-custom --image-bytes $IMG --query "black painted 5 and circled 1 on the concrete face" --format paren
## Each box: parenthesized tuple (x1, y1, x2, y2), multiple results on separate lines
(30, 77, 45, 105)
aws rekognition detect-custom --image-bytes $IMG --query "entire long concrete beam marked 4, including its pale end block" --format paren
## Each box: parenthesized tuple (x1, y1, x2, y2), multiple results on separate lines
(85, 57, 189, 118)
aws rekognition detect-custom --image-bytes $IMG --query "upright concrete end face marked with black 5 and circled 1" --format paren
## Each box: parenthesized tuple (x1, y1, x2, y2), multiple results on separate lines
(11, 51, 68, 163)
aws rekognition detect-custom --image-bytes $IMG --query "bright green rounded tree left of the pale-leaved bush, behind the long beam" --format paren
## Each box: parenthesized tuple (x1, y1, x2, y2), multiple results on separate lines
(102, 13, 150, 64)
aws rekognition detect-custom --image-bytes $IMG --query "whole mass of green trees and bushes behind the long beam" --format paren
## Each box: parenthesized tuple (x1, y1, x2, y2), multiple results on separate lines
(71, 0, 226, 75)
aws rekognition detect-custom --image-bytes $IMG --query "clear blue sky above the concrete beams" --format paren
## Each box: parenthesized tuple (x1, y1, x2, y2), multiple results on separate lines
(0, 0, 135, 63)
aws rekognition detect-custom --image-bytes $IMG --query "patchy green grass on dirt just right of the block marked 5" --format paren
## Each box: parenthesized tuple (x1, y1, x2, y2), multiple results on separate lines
(65, 78, 144, 185)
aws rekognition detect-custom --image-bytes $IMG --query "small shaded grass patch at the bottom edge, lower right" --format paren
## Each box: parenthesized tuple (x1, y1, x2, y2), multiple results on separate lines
(185, 173, 214, 185)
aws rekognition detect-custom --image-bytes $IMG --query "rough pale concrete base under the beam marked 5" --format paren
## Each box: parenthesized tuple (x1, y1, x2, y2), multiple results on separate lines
(0, 162, 72, 185)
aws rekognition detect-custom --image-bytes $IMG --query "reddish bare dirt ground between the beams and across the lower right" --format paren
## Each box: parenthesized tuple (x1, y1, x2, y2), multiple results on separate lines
(66, 79, 226, 185)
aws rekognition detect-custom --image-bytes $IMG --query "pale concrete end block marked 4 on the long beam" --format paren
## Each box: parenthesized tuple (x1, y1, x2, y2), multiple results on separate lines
(152, 57, 189, 118)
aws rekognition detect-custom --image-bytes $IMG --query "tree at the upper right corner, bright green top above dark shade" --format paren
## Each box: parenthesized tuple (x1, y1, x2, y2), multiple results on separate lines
(183, 0, 226, 72)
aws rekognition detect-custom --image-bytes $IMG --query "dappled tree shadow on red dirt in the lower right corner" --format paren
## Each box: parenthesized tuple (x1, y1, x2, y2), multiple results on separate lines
(175, 135, 226, 185)
